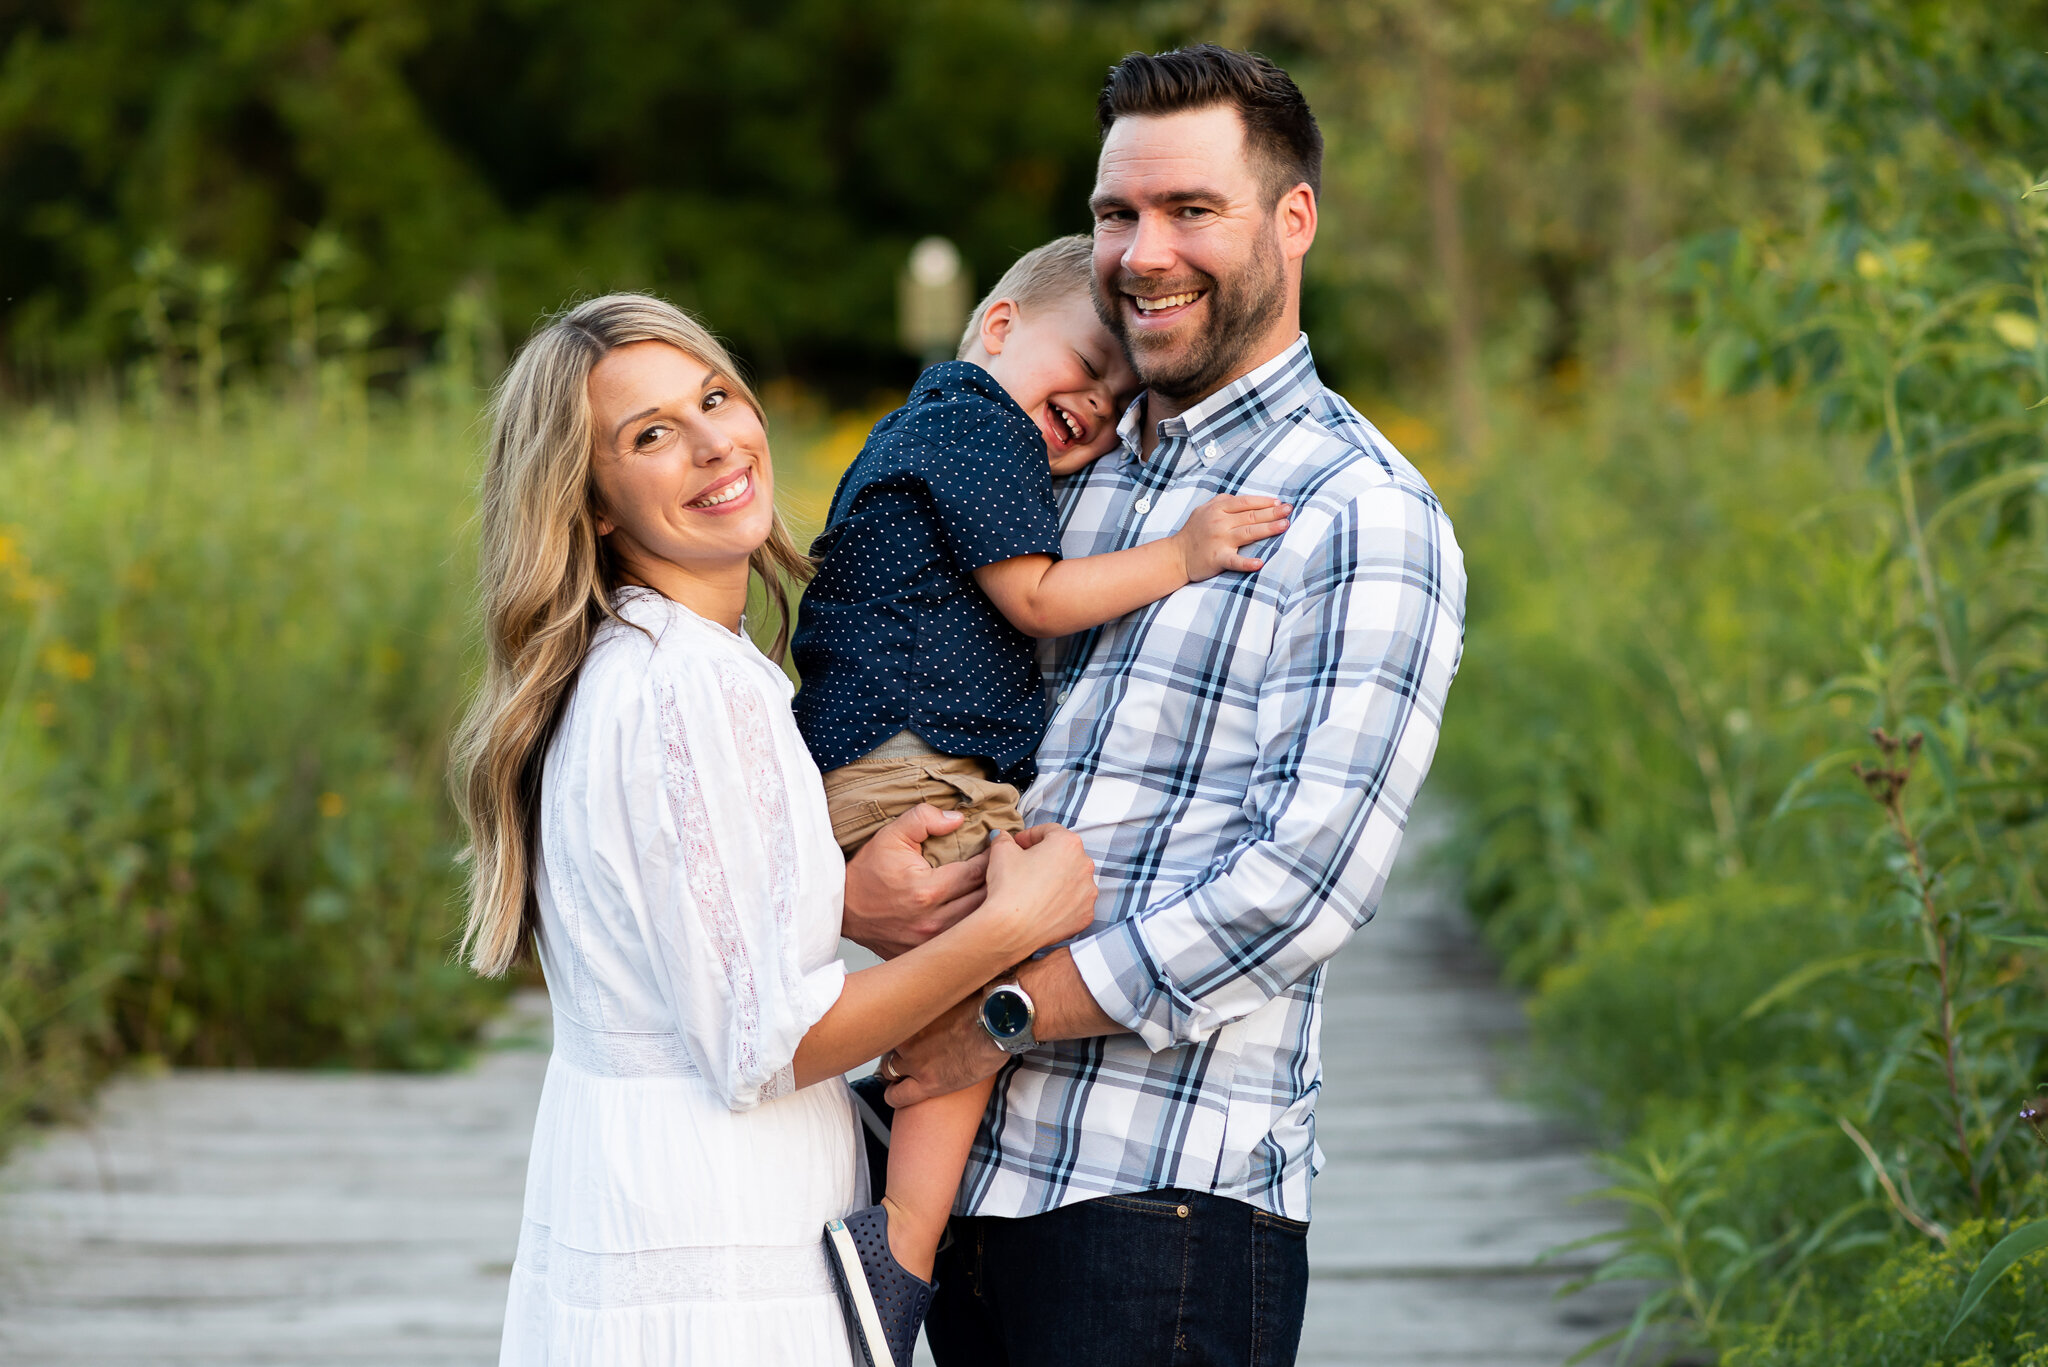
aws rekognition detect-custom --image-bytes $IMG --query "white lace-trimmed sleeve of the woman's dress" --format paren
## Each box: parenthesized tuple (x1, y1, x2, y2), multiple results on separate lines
(602, 648, 846, 1111)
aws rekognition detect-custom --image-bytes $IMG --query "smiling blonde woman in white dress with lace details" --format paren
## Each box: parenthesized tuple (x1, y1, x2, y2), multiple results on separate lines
(444, 295, 1094, 1367)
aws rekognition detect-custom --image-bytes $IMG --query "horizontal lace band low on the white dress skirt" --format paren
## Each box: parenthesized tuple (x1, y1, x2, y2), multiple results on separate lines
(514, 1219, 834, 1310)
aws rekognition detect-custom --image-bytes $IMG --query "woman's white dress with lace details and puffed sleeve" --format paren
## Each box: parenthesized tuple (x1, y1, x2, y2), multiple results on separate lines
(512, 590, 866, 1367)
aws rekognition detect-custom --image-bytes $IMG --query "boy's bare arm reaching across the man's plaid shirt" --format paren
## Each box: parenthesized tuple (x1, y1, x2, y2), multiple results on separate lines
(975, 494, 1290, 635)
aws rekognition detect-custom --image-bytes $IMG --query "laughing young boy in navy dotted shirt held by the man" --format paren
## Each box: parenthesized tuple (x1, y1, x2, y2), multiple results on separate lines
(795, 236, 1288, 1367)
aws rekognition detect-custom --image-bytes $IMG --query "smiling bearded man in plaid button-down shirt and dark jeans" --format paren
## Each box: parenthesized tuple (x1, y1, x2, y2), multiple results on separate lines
(864, 45, 1464, 1367)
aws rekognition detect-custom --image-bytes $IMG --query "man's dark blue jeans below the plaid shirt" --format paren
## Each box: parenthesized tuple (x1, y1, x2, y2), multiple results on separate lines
(926, 1189, 1309, 1367)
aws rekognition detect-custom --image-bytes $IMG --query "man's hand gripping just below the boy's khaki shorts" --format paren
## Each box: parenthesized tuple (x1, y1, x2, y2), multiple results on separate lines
(840, 803, 993, 963)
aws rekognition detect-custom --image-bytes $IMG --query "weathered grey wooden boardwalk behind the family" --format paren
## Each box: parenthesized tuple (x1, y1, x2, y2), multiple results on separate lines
(0, 840, 1626, 1367)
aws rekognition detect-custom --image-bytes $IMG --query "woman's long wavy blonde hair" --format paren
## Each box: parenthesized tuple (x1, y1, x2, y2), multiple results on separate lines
(453, 295, 811, 976)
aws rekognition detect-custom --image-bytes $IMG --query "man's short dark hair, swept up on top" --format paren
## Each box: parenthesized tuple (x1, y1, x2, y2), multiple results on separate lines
(1096, 43, 1323, 203)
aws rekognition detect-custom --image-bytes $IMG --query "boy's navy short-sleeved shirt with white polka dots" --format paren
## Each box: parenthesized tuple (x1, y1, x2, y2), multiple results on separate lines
(795, 361, 1059, 789)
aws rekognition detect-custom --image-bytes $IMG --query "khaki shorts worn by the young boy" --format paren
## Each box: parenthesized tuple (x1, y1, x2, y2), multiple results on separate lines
(825, 754, 1024, 869)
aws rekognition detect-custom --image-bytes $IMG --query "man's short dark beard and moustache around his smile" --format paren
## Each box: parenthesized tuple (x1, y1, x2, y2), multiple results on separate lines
(1096, 234, 1286, 404)
